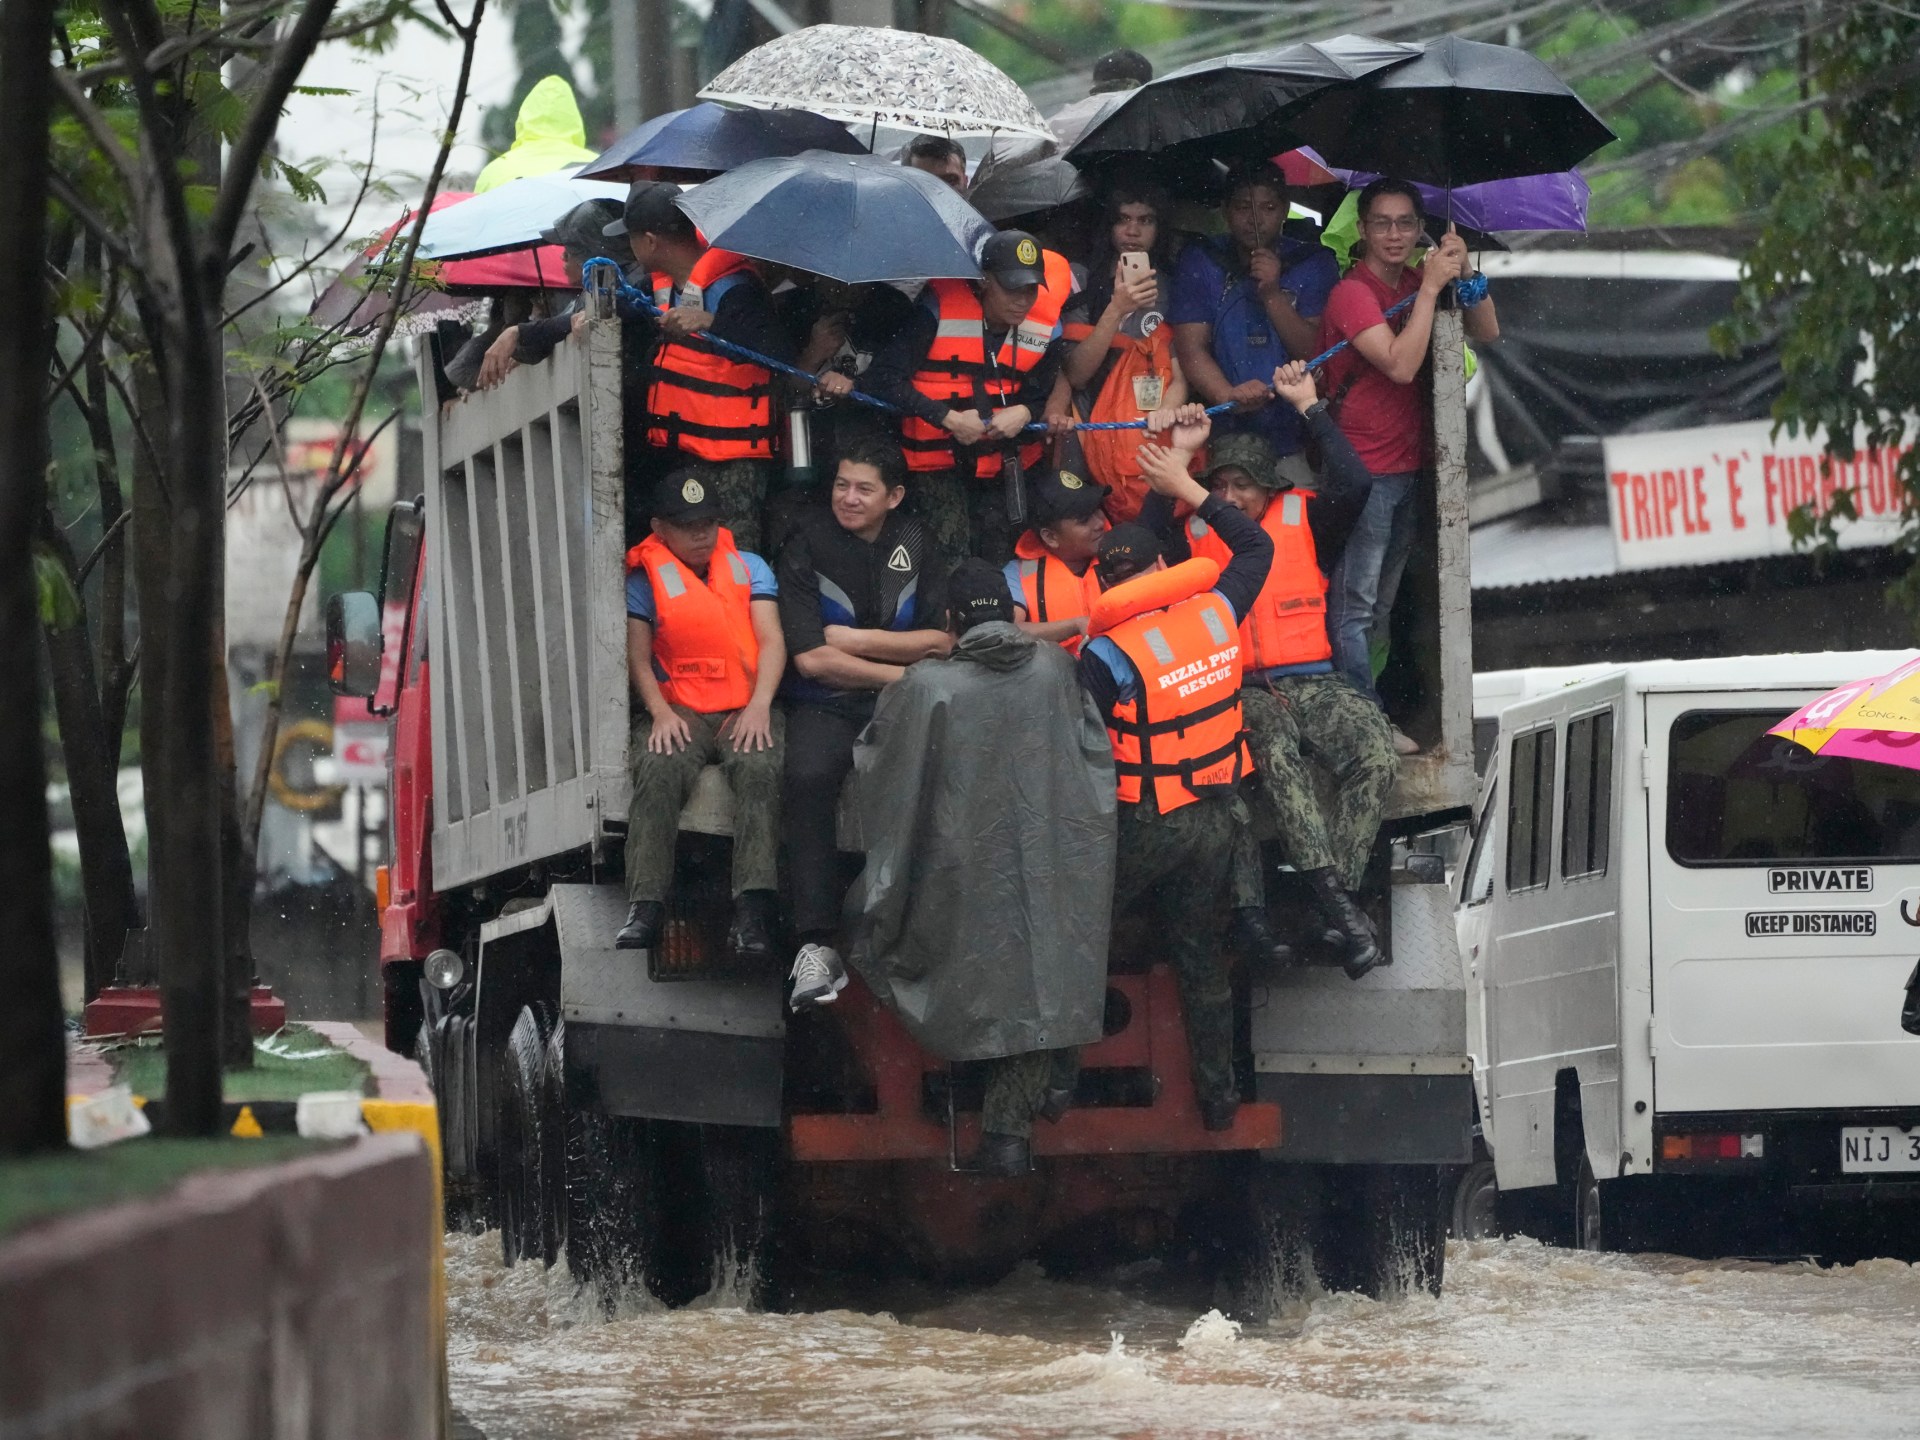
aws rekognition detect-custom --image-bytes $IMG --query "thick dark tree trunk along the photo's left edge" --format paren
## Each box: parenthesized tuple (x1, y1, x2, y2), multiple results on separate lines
(0, 0, 67, 1156)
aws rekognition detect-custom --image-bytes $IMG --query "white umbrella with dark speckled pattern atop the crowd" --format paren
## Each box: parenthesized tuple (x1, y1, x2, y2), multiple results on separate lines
(701, 25, 1054, 146)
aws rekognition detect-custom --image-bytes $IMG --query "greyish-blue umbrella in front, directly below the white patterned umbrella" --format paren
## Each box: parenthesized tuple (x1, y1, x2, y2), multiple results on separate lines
(676, 150, 993, 284)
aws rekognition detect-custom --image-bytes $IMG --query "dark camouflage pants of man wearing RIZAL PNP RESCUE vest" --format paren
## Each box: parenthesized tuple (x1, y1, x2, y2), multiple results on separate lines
(1114, 797, 1235, 1096)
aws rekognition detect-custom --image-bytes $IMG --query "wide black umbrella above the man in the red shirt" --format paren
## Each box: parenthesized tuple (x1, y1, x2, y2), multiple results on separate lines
(1290, 35, 1615, 186)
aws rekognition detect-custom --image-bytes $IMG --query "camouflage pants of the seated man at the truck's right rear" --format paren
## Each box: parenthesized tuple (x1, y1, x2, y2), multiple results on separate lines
(1233, 676, 1400, 904)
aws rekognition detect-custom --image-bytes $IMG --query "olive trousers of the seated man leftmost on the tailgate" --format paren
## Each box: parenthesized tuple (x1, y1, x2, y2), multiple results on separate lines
(626, 705, 785, 900)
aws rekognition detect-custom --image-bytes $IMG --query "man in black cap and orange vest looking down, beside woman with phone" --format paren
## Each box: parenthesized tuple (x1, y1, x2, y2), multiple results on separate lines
(866, 230, 1073, 564)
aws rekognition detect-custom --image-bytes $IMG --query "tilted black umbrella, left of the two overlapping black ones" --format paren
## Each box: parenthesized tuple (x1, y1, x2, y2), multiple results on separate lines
(1066, 35, 1420, 169)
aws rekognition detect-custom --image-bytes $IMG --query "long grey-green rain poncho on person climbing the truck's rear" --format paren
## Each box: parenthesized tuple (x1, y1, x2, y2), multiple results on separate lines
(847, 622, 1116, 1060)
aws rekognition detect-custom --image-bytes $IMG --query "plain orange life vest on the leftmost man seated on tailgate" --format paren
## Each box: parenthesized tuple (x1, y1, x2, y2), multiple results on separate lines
(626, 526, 760, 714)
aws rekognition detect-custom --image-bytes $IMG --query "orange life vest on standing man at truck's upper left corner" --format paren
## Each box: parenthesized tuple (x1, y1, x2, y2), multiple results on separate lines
(647, 250, 778, 461)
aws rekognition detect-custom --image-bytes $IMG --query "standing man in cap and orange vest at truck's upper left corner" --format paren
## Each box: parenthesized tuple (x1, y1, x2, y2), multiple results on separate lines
(609, 180, 795, 549)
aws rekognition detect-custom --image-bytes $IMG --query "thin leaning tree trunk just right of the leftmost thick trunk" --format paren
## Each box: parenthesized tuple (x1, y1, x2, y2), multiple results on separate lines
(40, 513, 138, 1000)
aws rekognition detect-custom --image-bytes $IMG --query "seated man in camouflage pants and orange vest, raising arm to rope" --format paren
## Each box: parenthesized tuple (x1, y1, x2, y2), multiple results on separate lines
(1142, 361, 1398, 979)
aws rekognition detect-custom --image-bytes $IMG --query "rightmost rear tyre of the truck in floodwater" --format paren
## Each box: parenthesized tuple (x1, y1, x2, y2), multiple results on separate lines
(1315, 1165, 1452, 1300)
